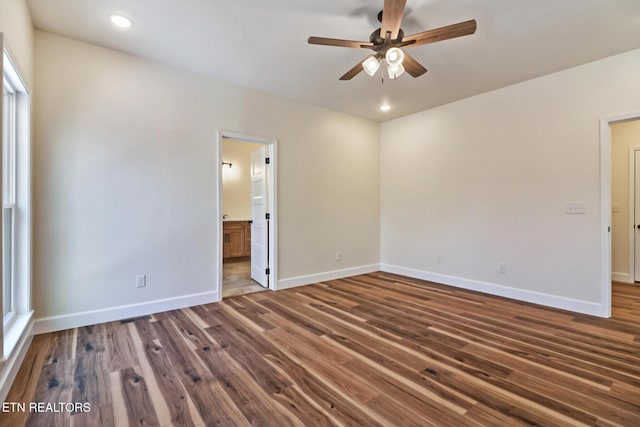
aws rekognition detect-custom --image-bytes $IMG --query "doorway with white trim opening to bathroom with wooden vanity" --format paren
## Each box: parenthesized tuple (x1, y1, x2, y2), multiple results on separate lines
(217, 131, 277, 300)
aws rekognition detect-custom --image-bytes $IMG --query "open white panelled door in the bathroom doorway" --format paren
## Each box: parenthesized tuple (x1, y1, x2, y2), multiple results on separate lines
(251, 145, 269, 288)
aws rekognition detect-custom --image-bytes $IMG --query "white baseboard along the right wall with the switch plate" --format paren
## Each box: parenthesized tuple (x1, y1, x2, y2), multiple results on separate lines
(380, 264, 608, 317)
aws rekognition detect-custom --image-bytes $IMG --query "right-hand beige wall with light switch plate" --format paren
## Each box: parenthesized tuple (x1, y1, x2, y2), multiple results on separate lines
(381, 50, 640, 314)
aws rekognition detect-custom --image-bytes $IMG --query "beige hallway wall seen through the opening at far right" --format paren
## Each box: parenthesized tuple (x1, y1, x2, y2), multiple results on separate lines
(611, 120, 640, 282)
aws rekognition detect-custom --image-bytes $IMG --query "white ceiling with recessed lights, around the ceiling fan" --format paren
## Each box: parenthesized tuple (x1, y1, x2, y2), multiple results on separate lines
(27, 0, 640, 121)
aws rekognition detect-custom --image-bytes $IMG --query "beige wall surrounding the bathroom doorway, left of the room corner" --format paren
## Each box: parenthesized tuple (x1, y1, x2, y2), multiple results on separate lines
(34, 31, 380, 320)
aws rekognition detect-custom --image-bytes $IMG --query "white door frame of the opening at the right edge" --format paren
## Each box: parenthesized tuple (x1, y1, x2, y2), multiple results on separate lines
(600, 111, 640, 317)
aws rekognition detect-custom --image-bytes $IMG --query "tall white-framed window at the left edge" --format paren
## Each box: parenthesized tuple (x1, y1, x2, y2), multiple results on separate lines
(0, 39, 33, 361)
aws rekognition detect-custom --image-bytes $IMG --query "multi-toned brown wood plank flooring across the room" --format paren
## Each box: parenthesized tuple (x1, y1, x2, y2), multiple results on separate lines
(0, 273, 640, 427)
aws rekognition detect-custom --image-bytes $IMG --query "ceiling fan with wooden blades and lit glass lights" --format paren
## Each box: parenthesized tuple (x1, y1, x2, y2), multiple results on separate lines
(308, 0, 476, 80)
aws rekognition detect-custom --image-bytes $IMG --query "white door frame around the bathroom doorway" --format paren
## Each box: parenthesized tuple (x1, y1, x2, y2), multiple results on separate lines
(215, 129, 278, 301)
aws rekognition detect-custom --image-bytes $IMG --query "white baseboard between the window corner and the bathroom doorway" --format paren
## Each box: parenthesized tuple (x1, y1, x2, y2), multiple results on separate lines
(34, 291, 218, 335)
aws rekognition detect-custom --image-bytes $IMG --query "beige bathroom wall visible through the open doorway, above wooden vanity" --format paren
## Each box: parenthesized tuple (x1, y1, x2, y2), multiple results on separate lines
(222, 139, 261, 220)
